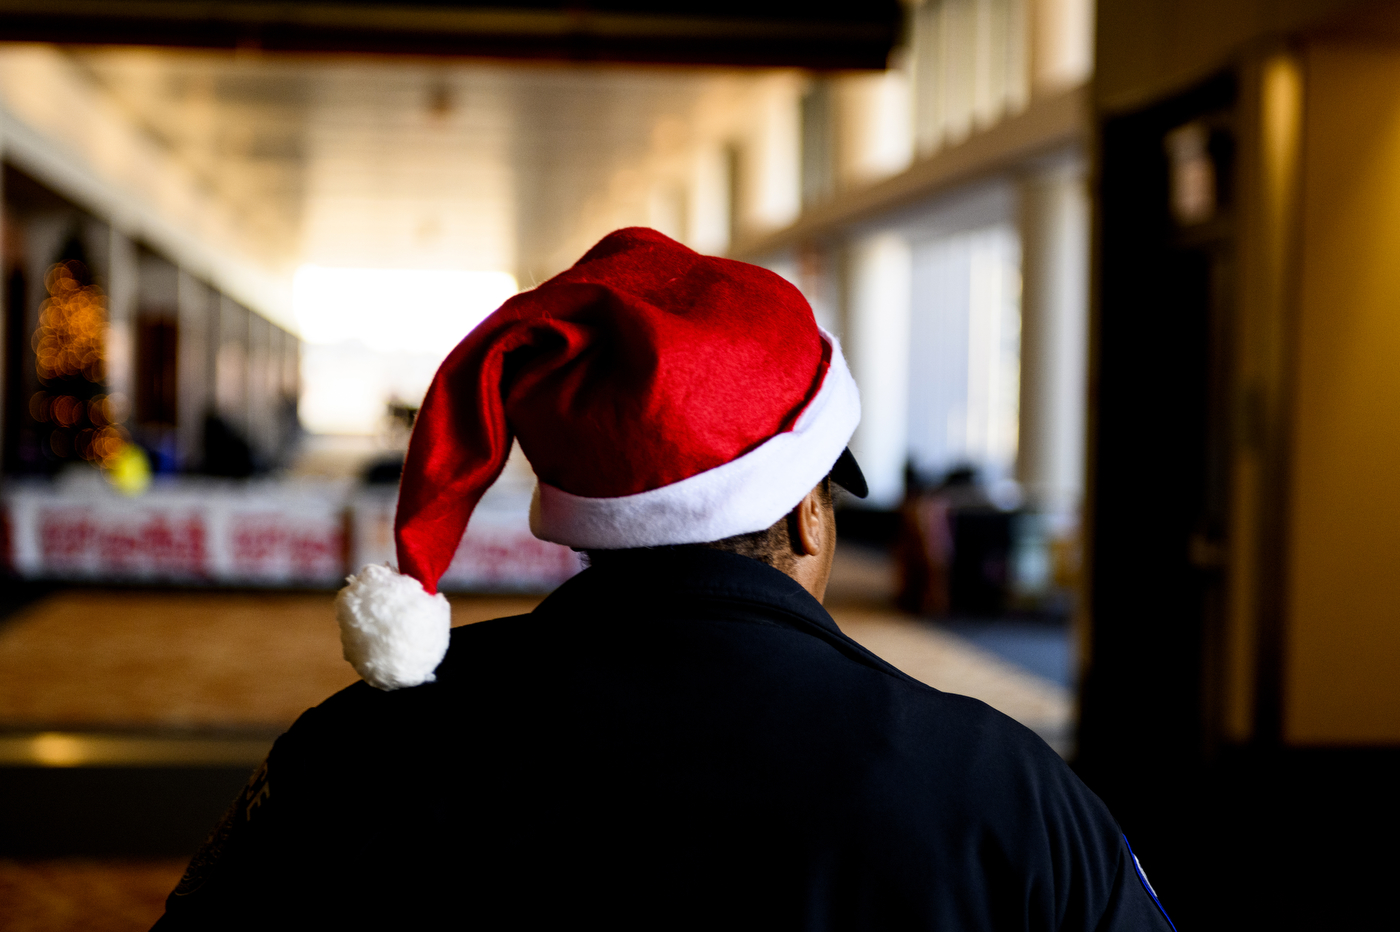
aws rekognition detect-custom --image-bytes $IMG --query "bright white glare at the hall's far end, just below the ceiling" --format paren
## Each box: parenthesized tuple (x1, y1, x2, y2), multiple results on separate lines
(293, 266, 517, 357)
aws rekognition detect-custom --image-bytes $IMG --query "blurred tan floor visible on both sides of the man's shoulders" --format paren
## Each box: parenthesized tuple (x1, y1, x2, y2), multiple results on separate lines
(0, 589, 1072, 743)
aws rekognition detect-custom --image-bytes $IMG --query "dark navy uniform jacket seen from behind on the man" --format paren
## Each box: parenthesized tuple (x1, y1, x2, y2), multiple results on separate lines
(157, 549, 1170, 932)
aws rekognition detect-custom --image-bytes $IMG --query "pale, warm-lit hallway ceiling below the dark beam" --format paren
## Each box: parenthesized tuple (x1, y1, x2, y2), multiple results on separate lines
(69, 48, 739, 275)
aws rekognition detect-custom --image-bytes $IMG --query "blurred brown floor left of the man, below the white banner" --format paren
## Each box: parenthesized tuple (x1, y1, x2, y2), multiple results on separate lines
(0, 589, 539, 730)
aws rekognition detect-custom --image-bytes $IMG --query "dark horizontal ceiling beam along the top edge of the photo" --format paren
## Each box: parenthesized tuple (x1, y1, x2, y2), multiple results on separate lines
(0, 0, 902, 70)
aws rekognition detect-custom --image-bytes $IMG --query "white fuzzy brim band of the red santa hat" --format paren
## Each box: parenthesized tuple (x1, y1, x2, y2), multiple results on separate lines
(529, 330, 861, 550)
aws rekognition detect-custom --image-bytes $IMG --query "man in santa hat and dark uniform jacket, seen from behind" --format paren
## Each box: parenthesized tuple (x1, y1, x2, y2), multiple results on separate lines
(157, 228, 1170, 931)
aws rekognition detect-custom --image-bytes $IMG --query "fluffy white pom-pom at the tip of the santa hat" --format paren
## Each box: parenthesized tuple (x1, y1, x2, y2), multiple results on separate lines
(336, 565, 452, 690)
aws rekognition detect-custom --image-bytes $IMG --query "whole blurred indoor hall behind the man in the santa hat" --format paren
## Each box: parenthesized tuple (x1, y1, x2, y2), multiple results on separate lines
(0, 0, 1400, 931)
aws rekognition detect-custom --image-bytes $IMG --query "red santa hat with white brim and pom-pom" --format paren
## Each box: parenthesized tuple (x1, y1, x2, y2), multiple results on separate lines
(336, 228, 865, 690)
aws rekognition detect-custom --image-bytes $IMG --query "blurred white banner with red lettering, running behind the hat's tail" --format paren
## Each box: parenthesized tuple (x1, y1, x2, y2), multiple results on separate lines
(0, 479, 581, 592)
